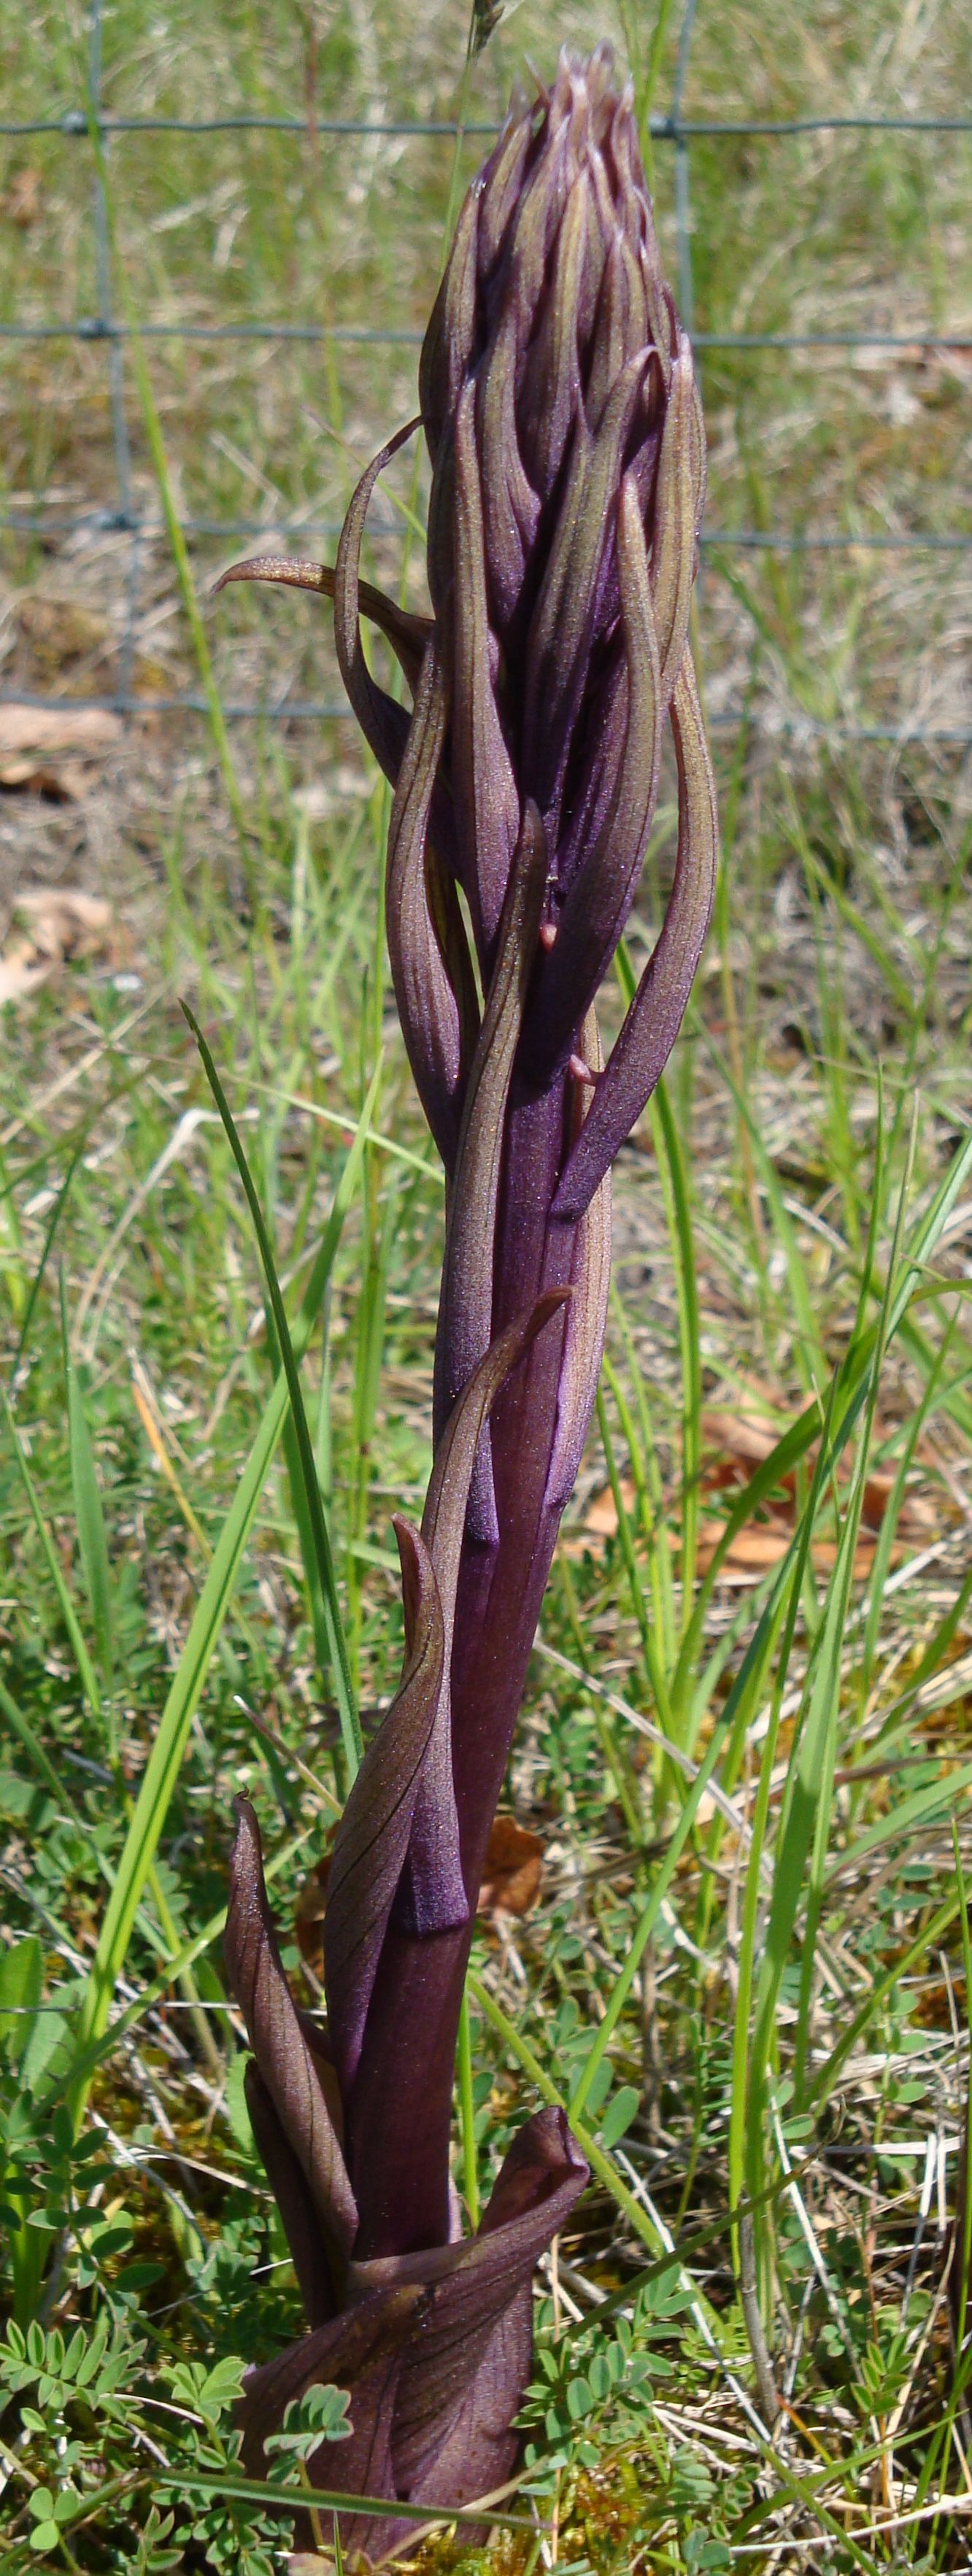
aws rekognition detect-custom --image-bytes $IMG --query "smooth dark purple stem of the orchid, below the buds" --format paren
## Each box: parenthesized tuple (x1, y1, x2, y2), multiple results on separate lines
(345, 1082, 582, 2262)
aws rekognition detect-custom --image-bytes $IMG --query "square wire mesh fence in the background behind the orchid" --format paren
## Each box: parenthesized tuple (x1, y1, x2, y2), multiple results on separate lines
(0, 0, 972, 747)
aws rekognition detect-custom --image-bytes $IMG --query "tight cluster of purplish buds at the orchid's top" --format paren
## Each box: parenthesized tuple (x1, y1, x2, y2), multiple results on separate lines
(420, 47, 711, 1118)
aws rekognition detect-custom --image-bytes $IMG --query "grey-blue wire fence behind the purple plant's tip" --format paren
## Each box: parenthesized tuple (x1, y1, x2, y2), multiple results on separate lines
(0, 0, 972, 747)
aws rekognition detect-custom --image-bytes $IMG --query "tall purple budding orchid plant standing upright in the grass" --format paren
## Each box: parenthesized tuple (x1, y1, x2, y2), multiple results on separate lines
(215, 47, 717, 2563)
